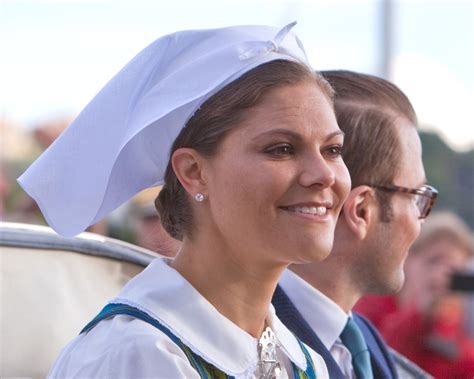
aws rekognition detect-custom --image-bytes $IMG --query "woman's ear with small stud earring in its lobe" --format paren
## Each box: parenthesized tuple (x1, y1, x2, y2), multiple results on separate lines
(171, 147, 207, 197)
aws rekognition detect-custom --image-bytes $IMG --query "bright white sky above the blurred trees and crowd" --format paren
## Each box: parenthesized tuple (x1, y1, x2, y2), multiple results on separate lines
(0, 0, 474, 150)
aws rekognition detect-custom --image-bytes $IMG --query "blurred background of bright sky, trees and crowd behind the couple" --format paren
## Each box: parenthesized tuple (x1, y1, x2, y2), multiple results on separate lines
(0, 0, 474, 377)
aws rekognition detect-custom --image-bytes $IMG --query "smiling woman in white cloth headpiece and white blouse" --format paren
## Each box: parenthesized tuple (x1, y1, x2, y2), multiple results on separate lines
(20, 24, 350, 378)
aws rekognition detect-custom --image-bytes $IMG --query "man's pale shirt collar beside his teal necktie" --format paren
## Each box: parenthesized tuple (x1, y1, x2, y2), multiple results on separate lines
(279, 270, 349, 350)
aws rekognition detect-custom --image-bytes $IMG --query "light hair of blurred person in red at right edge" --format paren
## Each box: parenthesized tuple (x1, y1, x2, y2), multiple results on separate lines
(410, 211, 474, 255)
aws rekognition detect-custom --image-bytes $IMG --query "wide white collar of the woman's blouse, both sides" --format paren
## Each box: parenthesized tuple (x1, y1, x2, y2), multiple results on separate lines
(111, 258, 306, 376)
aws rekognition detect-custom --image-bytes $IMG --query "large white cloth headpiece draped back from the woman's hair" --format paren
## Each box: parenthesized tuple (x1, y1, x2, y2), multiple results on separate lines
(18, 23, 309, 237)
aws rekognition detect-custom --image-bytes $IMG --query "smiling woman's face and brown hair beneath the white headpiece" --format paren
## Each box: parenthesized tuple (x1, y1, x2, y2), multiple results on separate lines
(157, 61, 349, 272)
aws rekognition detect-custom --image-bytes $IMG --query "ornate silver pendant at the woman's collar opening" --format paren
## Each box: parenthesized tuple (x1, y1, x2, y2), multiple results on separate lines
(255, 327, 281, 379)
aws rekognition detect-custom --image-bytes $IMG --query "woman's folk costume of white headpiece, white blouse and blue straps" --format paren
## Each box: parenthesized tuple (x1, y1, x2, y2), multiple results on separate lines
(18, 23, 328, 378)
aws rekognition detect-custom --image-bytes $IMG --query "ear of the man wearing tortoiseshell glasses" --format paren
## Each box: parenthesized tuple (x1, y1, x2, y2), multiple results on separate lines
(342, 185, 378, 240)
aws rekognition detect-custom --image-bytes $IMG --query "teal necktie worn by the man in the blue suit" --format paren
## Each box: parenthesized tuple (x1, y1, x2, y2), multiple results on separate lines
(341, 318, 374, 379)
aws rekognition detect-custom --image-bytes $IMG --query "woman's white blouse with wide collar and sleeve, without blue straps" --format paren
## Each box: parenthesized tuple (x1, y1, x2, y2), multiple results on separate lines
(49, 259, 329, 379)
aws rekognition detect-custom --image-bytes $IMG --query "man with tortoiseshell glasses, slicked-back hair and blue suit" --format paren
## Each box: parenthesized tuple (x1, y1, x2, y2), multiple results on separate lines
(273, 71, 437, 379)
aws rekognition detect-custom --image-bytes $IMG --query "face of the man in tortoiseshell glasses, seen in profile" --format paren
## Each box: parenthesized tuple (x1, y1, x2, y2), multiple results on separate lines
(365, 119, 425, 293)
